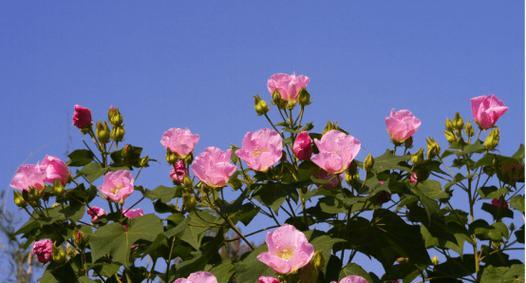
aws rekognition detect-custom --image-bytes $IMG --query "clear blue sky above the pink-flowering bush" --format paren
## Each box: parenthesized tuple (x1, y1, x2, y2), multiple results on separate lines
(0, 0, 524, 280)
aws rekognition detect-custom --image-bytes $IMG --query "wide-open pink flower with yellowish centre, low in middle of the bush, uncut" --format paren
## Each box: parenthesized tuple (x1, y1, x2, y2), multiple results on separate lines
(257, 224, 314, 274)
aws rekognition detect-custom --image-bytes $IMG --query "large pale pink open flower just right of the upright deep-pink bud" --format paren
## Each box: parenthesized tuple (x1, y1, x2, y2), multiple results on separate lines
(311, 130, 361, 174)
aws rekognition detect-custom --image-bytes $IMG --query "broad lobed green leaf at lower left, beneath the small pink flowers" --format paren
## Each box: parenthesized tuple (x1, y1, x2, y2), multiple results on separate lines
(90, 214, 163, 265)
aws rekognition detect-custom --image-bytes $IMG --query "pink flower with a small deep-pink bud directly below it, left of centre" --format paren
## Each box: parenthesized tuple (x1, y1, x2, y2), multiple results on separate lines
(161, 128, 199, 158)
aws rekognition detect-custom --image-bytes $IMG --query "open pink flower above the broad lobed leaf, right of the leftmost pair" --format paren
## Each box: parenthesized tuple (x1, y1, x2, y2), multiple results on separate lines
(99, 170, 134, 203)
